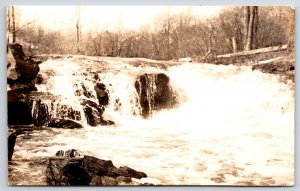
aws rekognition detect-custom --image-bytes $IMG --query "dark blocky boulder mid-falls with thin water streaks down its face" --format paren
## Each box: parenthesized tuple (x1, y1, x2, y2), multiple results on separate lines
(134, 73, 177, 118)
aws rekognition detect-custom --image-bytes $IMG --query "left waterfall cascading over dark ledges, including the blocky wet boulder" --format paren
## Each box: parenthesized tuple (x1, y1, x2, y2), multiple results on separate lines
(32, 57, 178, 126)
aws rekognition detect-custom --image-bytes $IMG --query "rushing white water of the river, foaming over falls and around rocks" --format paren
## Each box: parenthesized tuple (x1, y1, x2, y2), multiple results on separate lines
(10, 58, 294, 186)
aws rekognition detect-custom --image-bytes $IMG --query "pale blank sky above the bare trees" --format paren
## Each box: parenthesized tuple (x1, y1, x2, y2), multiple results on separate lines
(17, 6, 222, 31)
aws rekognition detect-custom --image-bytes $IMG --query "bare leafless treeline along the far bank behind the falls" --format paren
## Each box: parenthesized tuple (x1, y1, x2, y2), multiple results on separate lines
(11, 7, 292, 60)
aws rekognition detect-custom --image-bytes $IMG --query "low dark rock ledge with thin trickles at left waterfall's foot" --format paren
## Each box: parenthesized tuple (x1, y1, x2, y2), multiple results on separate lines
(8, 90, 114, 128)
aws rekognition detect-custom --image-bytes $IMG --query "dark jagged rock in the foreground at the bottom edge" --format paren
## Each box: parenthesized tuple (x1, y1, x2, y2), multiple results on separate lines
(46, 155, 147, 186)
